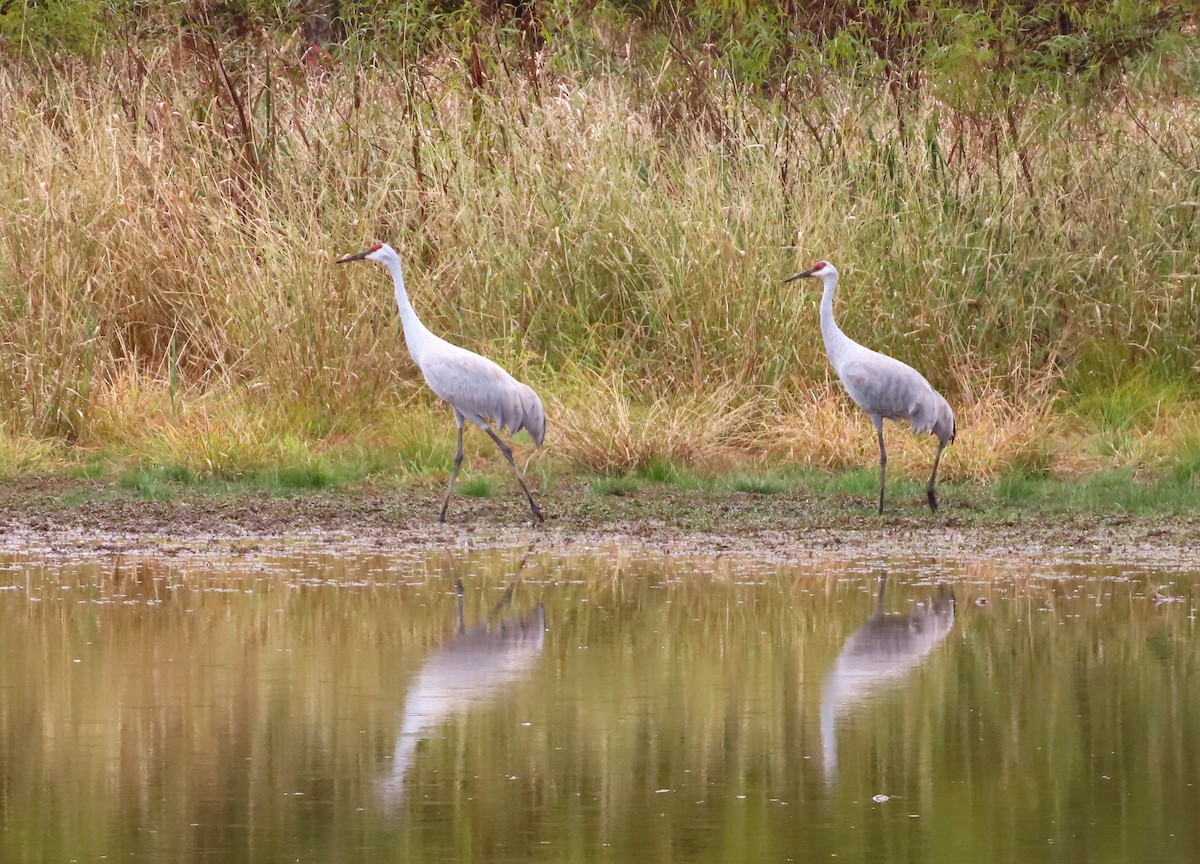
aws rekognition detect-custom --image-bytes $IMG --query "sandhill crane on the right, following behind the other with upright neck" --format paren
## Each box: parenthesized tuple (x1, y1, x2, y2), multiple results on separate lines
(784, 262, 955, 514)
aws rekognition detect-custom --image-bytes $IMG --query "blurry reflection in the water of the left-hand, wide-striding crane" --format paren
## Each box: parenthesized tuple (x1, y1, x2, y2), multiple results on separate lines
(379, 559, 546, 810)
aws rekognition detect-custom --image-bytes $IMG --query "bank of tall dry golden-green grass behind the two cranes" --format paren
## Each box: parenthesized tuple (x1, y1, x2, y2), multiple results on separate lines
(0, 3, 1200, 499)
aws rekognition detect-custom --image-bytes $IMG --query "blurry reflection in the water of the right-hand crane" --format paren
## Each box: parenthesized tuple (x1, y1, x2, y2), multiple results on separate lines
(821, 574, 954, 784)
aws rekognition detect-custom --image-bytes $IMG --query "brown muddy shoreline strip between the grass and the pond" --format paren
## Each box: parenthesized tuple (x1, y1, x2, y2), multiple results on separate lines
(0, 480, 1200, 568)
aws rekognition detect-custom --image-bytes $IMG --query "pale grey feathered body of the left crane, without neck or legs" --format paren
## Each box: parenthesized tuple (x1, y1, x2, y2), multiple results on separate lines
(421, 342, 546, 446)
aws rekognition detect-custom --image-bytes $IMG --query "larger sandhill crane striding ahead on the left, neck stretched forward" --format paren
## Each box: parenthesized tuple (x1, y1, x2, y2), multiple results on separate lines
(337, 244, 546, 522)
